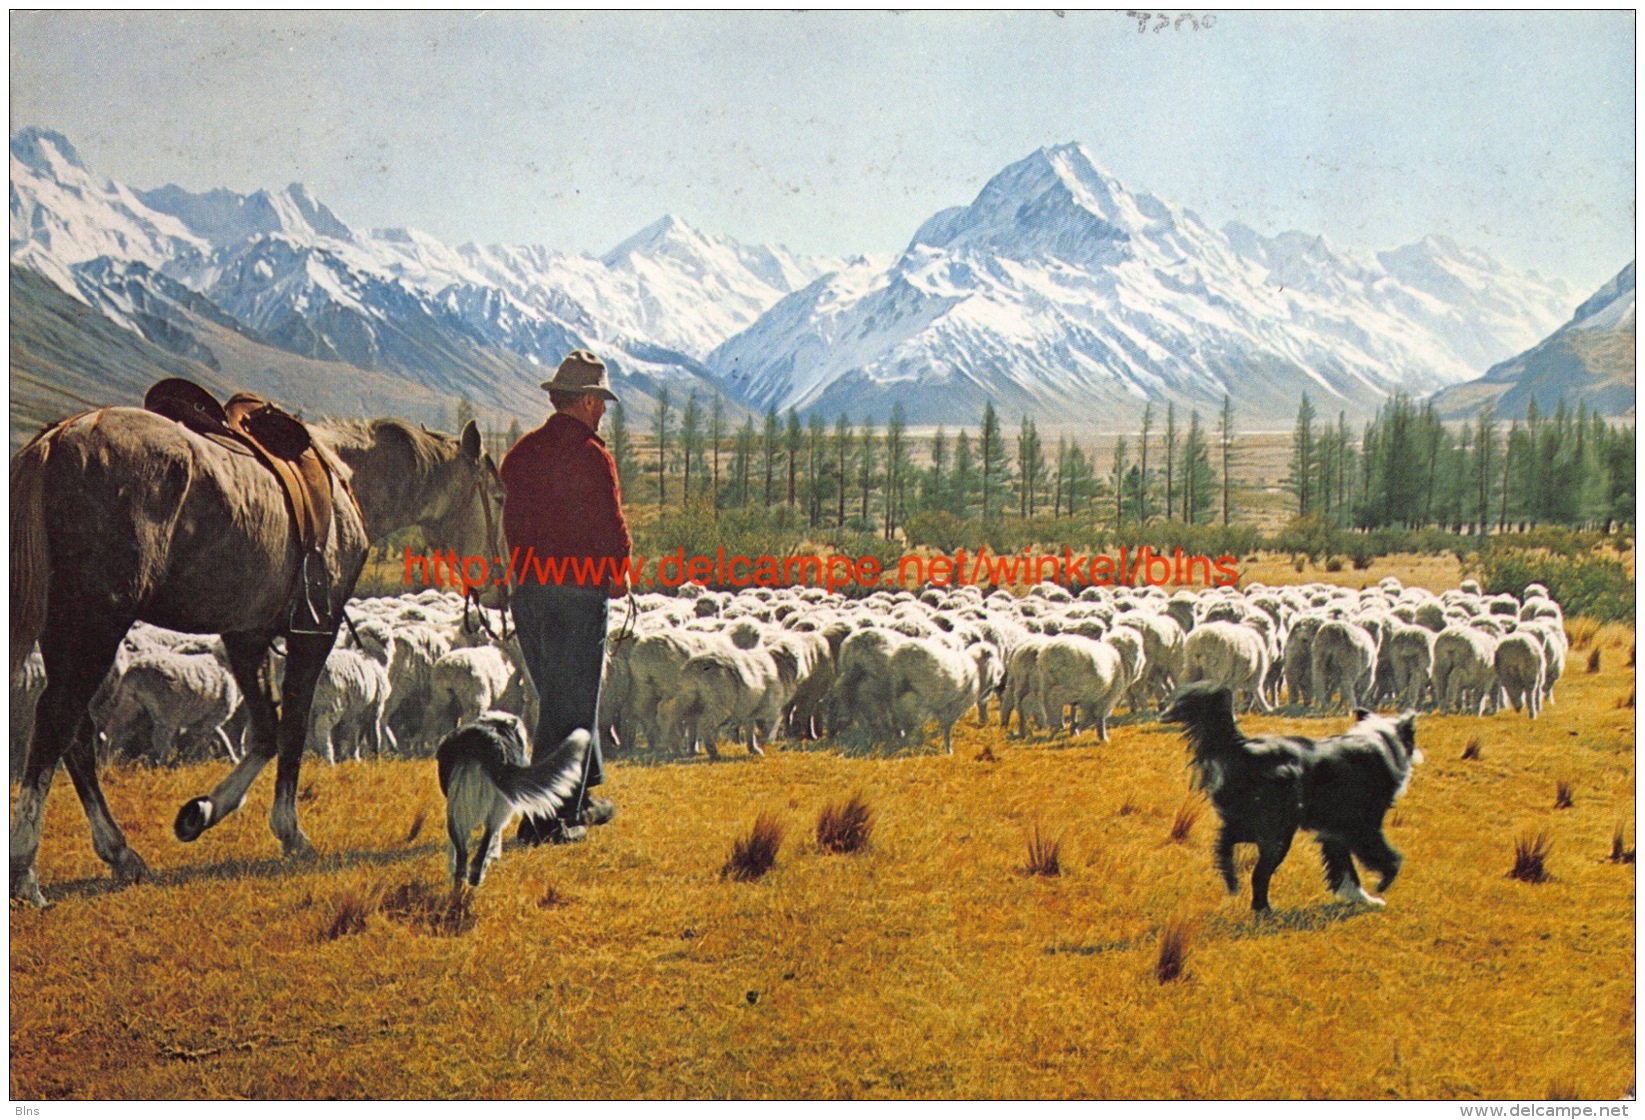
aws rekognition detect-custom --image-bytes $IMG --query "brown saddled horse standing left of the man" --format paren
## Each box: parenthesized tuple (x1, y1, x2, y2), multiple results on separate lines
(12, 408, 502, 905)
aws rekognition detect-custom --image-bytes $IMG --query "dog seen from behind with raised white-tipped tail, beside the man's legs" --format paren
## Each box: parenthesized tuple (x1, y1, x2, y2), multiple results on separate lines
(434, 712, 589, 886)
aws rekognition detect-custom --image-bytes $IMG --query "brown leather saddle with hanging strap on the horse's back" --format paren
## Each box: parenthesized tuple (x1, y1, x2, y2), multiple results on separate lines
(143, 377, 334, 633)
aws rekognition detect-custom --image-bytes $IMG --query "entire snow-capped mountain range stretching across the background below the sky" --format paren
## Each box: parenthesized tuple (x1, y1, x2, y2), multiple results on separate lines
(12, 128, 1632, 444)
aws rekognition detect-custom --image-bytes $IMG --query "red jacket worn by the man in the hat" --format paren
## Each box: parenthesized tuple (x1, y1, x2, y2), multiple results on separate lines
(498, 413, 633, 585)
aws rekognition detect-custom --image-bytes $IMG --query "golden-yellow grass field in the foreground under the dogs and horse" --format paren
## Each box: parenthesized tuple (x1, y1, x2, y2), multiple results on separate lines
(8, 615, 1637, 1100)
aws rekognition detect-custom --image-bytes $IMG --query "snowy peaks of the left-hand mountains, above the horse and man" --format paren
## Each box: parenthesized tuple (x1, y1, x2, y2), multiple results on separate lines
(12, 128, 832, 414)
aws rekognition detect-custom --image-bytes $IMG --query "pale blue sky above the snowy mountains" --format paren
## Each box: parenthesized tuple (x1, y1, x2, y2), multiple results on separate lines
(10, 12, 1635, 293)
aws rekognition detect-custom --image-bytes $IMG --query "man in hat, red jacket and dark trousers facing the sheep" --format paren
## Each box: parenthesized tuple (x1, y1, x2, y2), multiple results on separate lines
(500, 350, 632, 844)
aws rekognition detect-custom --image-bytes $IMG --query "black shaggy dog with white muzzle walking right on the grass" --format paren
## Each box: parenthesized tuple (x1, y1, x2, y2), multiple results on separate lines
(1160, 683, 1423, 913)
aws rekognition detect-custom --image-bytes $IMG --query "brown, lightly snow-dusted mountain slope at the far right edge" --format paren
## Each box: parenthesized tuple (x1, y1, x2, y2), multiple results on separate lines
(1434, 261, 1637, 419)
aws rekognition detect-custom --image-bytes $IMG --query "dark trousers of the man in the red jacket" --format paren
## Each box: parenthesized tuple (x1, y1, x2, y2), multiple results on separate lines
(512, 582, 610, 835)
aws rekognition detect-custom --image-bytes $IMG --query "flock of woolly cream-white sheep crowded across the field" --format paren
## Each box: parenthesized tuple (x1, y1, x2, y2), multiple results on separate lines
(12, 579, 1568, 773)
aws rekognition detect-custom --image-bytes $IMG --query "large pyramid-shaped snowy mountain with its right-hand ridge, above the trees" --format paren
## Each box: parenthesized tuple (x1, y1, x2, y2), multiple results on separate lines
(707, 145, 1568, 423)
